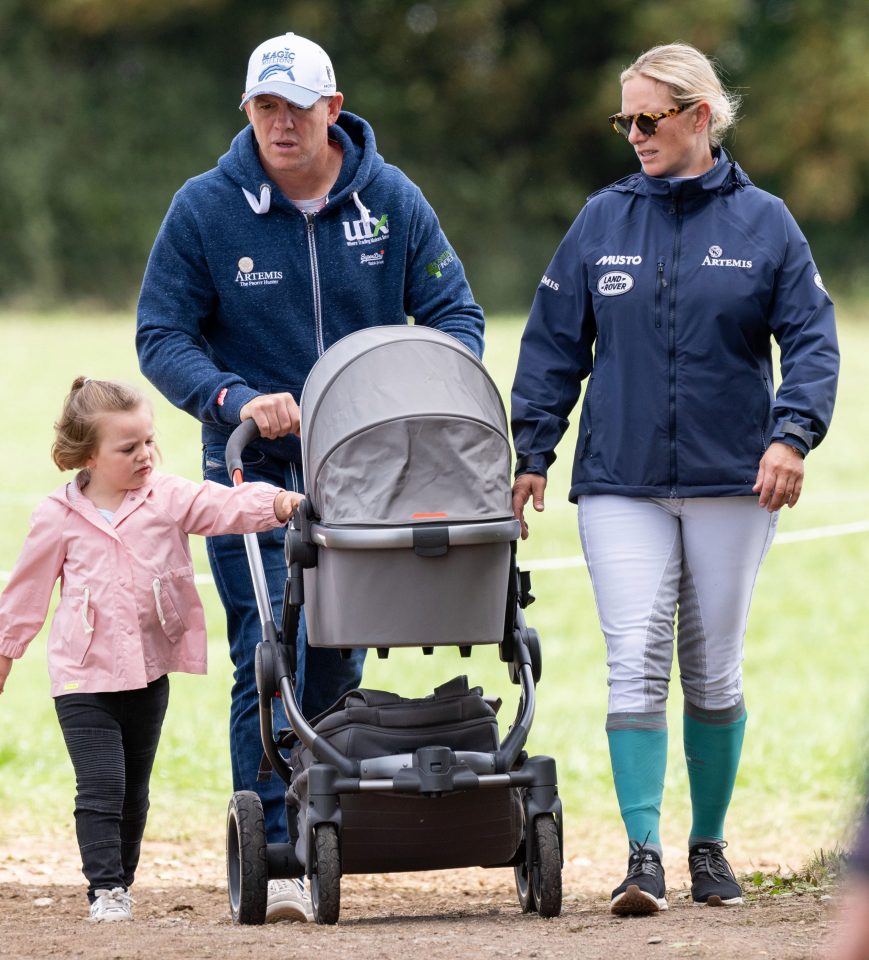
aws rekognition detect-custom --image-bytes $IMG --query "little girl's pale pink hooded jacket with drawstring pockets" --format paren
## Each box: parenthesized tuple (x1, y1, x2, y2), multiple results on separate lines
(0, 474, 280, 697)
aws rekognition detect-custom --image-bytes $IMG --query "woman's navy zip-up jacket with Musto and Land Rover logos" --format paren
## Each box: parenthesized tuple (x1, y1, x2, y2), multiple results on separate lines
(512, 150, 839, 501)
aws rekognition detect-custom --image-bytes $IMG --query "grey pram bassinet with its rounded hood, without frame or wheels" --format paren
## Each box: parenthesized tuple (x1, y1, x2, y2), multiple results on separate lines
(301, 327, 517, 648)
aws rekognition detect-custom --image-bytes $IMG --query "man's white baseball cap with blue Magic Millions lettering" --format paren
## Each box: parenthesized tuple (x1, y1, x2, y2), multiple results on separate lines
(239, 33, 335, 110)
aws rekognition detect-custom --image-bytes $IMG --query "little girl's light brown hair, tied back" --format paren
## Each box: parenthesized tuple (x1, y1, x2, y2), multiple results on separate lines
(51, 377, 148, 470)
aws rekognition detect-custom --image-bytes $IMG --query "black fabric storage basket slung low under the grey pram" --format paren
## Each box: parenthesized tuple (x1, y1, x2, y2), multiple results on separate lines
(288, 676, 523, 873)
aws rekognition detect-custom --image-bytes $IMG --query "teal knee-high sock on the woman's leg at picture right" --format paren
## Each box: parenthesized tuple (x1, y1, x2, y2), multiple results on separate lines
(683, 703, 747, 844)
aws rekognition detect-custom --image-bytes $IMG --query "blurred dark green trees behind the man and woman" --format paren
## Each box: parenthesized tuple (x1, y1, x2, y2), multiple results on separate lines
(0, 0, 869, 310)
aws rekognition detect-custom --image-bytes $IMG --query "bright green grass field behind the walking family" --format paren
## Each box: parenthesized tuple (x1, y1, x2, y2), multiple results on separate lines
(0, 305, 869, 866)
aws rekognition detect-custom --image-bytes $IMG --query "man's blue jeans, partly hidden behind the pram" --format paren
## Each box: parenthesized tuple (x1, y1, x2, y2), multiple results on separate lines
(203, 443, 365, 843)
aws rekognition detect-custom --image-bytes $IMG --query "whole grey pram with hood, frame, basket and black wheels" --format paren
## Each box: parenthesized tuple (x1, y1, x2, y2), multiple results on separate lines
(226, 326, 562, 923)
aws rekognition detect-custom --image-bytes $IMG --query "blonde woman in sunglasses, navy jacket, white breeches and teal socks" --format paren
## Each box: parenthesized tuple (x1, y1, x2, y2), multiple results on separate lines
(512, 43, 838, 914)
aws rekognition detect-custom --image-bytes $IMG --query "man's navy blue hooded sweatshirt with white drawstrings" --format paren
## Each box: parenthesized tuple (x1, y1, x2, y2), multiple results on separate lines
(136, 112, 483, 461)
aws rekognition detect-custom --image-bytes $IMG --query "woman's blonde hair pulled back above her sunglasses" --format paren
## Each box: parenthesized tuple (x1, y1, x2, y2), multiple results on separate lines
(619, 43, 741, 146)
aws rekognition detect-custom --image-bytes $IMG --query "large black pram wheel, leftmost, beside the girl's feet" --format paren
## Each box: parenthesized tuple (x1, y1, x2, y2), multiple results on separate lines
(226, 790, 268, 924)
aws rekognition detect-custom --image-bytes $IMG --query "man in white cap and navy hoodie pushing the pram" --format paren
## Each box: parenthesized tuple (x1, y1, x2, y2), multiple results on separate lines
(136, 33, 483, 919)
